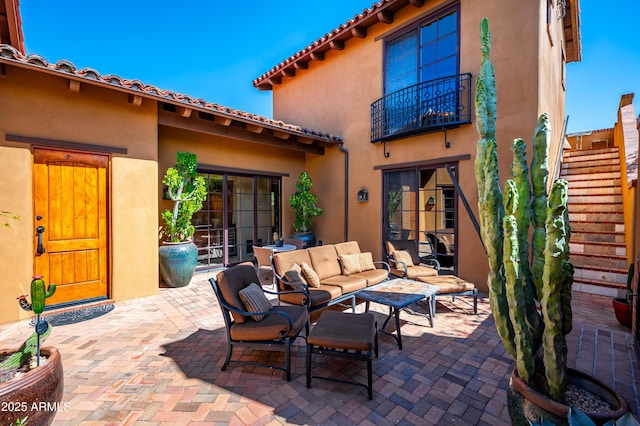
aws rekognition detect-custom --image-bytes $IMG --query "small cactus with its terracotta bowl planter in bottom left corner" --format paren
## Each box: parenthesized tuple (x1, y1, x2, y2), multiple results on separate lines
(0, 276, 64, 425)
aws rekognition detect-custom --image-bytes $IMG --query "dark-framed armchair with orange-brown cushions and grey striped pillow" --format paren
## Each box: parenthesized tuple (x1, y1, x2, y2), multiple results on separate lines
(209, 262, 309, 381)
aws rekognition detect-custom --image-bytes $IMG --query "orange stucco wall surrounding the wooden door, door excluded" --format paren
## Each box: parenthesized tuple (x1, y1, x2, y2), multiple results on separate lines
(0, 66, 158, 323)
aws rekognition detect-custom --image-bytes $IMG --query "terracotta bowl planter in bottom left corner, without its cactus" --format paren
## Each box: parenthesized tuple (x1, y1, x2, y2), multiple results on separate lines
(0, 347, 65, 425)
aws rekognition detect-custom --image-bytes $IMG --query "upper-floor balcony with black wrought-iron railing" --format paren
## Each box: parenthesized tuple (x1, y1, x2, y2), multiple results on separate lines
(371, 73, 471, 143)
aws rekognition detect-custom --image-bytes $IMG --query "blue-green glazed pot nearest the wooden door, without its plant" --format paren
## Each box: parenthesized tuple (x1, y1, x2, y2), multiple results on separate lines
(159, 241, 198, 287)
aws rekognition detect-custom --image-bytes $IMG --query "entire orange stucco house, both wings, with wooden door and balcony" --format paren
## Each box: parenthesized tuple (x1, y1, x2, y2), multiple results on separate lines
(0, 0, 581, 323)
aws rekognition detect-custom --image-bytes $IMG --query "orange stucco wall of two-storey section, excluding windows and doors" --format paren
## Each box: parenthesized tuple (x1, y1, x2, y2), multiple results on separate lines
(273, 0, 564, 290)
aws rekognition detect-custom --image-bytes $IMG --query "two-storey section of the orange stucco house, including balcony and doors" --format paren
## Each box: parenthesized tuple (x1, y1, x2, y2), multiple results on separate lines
(254, 0, 581, 290)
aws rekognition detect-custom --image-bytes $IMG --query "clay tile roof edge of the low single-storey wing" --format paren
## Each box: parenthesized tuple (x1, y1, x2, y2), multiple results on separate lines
(0, 44, 342, 145)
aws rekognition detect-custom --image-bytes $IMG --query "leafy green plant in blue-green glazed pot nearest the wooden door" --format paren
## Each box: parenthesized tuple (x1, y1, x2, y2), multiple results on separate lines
(159, 152, 207, 287)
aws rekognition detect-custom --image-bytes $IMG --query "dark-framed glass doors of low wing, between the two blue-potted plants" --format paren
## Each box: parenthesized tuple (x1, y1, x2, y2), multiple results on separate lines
(192, 172, 281, 270)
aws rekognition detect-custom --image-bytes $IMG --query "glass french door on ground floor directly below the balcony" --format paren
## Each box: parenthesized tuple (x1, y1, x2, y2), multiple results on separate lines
(383, 167, 458, 273)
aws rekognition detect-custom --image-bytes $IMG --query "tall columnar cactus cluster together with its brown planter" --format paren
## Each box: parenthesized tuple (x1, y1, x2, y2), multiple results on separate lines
(475, 19, 628, 425)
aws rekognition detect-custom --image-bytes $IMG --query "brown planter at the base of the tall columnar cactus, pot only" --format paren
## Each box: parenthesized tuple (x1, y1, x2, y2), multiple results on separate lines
(507, 368, 629, 426)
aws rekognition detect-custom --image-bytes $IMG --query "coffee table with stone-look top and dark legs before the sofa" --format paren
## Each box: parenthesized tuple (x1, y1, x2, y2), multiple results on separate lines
(356, 278, 440, 349)
